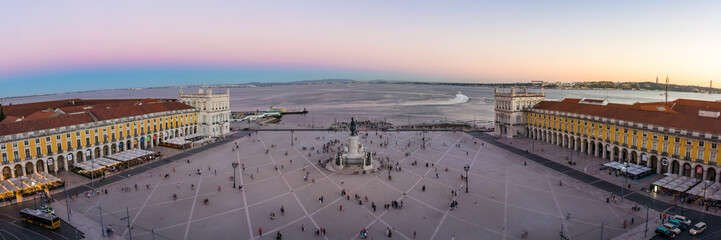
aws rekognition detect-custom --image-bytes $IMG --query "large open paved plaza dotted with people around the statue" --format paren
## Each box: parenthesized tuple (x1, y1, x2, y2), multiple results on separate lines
(54, 131, 642, 239)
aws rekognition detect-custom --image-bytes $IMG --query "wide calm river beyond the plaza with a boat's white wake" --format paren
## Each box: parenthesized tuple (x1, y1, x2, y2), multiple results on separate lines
(5, 84, 721, 127)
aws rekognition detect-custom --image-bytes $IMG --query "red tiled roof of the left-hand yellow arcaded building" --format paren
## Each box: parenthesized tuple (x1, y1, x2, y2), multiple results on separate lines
(0, 99, 193, 136)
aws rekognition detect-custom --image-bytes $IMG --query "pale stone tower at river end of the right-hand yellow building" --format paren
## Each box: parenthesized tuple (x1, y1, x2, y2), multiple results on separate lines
(493, 87, 546, 138)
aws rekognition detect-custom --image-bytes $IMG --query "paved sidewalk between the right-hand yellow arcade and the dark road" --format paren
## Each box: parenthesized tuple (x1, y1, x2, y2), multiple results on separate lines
(498, 137, 721, 216)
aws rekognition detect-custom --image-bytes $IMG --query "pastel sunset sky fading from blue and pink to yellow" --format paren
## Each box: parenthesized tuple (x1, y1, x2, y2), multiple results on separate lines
(0, 0, 721, 97)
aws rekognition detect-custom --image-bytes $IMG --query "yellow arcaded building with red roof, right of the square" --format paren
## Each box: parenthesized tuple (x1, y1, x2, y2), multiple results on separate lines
(525, 99, 721, 182)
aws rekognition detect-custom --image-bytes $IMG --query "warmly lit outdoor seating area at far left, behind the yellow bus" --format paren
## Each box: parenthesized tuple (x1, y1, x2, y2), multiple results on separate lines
(0, 172, 63, 201)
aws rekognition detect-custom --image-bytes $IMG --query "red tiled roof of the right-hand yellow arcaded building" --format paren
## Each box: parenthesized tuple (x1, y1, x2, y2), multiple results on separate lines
(533, 99, 721, 134)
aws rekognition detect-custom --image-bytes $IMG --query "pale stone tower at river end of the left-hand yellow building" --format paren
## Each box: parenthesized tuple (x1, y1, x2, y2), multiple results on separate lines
(180, 88, 230, 137)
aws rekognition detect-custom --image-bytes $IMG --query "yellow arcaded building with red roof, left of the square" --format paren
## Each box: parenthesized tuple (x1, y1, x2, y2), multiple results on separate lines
(0, 99, 198, 179)
